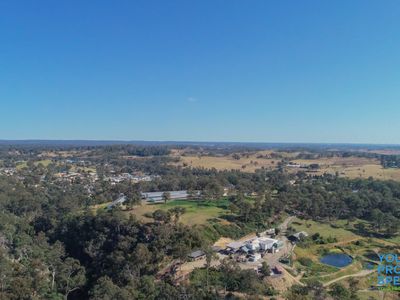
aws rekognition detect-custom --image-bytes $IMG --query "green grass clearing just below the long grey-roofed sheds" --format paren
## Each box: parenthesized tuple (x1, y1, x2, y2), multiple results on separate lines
(129, 199, 229, 225)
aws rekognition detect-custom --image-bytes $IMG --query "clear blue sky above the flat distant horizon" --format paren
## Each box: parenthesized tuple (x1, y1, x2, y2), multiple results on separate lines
(0, 0, 400, 144)
